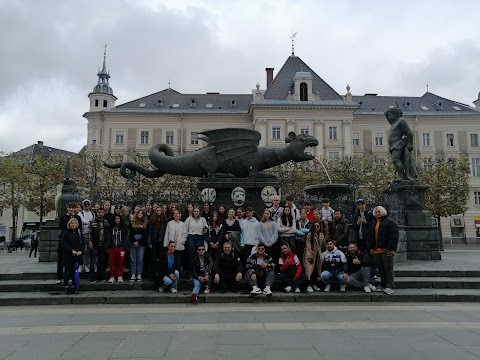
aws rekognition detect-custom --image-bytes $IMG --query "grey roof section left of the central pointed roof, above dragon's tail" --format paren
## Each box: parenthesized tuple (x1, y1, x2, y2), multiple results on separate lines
(110, 89, 253, 113)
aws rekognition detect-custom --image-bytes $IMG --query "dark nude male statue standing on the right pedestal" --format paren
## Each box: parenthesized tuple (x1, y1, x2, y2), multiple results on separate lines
(385, 108, 418, 180)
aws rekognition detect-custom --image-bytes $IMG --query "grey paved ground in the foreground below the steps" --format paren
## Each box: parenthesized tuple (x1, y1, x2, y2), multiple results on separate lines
(0, 303, 480, 360)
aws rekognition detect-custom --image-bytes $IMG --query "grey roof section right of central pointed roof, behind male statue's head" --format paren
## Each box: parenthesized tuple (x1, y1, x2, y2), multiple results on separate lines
(352, 92, 480, 115)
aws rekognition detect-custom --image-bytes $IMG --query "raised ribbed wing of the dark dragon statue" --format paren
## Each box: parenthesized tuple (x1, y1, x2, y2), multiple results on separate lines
(199, 128, 261, 161)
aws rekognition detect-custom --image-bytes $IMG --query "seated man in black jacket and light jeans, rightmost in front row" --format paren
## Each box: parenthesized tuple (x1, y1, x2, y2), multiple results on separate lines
(345, 243, 376, 293)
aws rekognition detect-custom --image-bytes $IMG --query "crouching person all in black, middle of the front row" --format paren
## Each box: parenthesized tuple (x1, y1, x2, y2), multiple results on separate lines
(213, 241, 243, 293)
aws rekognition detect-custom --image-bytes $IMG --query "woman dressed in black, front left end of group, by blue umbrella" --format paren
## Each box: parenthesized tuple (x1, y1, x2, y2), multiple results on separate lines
(62, 217, 84, 294)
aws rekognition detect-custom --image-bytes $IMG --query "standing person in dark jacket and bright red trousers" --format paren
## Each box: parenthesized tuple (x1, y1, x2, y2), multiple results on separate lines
(106, 214, 129, 284)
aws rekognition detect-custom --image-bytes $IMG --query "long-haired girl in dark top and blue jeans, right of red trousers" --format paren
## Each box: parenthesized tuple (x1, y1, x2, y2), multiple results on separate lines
(129, 209, 148, 281)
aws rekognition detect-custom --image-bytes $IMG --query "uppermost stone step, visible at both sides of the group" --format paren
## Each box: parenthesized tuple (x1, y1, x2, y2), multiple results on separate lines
(0, 265, 480, 281)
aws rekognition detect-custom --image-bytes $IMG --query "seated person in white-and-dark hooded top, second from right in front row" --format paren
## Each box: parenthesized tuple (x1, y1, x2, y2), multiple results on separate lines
(320, 239, 348, 292)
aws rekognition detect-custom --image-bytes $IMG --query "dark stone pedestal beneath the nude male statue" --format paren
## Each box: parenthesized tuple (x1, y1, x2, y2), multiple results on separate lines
(387, 181, 441, 262)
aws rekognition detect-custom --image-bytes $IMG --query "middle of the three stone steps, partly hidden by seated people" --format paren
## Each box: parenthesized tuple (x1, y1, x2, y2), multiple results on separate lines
(0, 277, 480, 292)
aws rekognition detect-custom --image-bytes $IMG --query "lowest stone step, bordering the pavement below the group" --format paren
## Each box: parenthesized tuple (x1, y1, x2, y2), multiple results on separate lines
(0, 289, 480, 306)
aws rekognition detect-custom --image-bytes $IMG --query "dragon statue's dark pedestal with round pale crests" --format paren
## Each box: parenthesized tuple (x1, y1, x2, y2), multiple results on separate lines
(197, 177, 280, 214)
